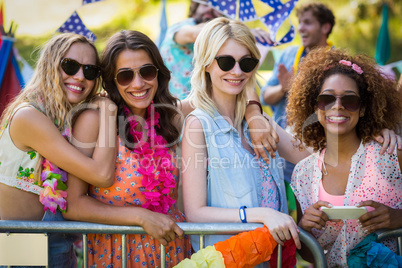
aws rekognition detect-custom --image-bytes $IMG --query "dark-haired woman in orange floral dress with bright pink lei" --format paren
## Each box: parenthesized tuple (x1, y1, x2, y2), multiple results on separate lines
(65, 31, 191, 267)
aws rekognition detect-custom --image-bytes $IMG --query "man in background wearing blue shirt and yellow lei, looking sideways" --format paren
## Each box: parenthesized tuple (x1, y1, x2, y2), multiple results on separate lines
(260, 2, 335, 183)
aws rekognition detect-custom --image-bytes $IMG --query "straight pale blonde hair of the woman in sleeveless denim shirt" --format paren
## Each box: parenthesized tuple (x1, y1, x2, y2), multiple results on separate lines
(189, 17, 261, 127)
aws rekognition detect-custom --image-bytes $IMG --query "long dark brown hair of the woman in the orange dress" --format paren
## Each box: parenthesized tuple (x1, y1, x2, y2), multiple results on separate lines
(101, 30, 180, 149)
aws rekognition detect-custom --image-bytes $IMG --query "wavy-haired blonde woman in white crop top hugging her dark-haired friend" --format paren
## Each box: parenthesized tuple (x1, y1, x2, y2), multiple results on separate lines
(0, 33, 116, 267)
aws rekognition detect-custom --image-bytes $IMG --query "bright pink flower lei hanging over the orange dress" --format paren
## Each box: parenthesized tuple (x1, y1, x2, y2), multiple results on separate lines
(123, 103, 176, 214)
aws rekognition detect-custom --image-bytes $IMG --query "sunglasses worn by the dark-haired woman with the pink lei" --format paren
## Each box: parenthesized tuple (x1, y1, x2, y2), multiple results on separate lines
(114, 65, 158, 86)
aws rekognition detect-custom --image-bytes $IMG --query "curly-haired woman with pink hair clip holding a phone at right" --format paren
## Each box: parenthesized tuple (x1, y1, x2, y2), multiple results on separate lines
(287, 49, 402, 267)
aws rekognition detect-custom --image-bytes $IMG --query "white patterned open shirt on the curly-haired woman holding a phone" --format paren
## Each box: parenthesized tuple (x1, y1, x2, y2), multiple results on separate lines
(291, 141, 402, 267)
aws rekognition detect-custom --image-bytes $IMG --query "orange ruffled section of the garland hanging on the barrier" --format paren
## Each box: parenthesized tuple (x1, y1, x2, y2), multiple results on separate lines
(214, 226, 277, 268)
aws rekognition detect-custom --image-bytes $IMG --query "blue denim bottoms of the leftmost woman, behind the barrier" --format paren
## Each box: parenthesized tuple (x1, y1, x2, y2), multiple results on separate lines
(0, 210, 81, 268)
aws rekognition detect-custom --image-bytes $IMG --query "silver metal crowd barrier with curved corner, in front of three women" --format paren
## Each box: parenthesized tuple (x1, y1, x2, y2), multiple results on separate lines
(0, 220, 327, 268)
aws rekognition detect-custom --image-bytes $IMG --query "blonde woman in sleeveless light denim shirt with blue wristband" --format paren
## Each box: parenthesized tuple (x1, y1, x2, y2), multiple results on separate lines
(182, 18, 308, 264)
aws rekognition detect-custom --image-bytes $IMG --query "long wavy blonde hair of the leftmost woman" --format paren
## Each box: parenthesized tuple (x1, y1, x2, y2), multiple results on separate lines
(0, 33, 100, 131)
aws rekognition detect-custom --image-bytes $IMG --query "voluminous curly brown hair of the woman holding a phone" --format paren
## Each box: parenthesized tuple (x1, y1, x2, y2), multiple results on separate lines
(286, 48, 401, 150)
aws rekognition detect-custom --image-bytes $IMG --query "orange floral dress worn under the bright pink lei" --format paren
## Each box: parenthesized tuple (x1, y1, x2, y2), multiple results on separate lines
(88, 139, 191, 268)
